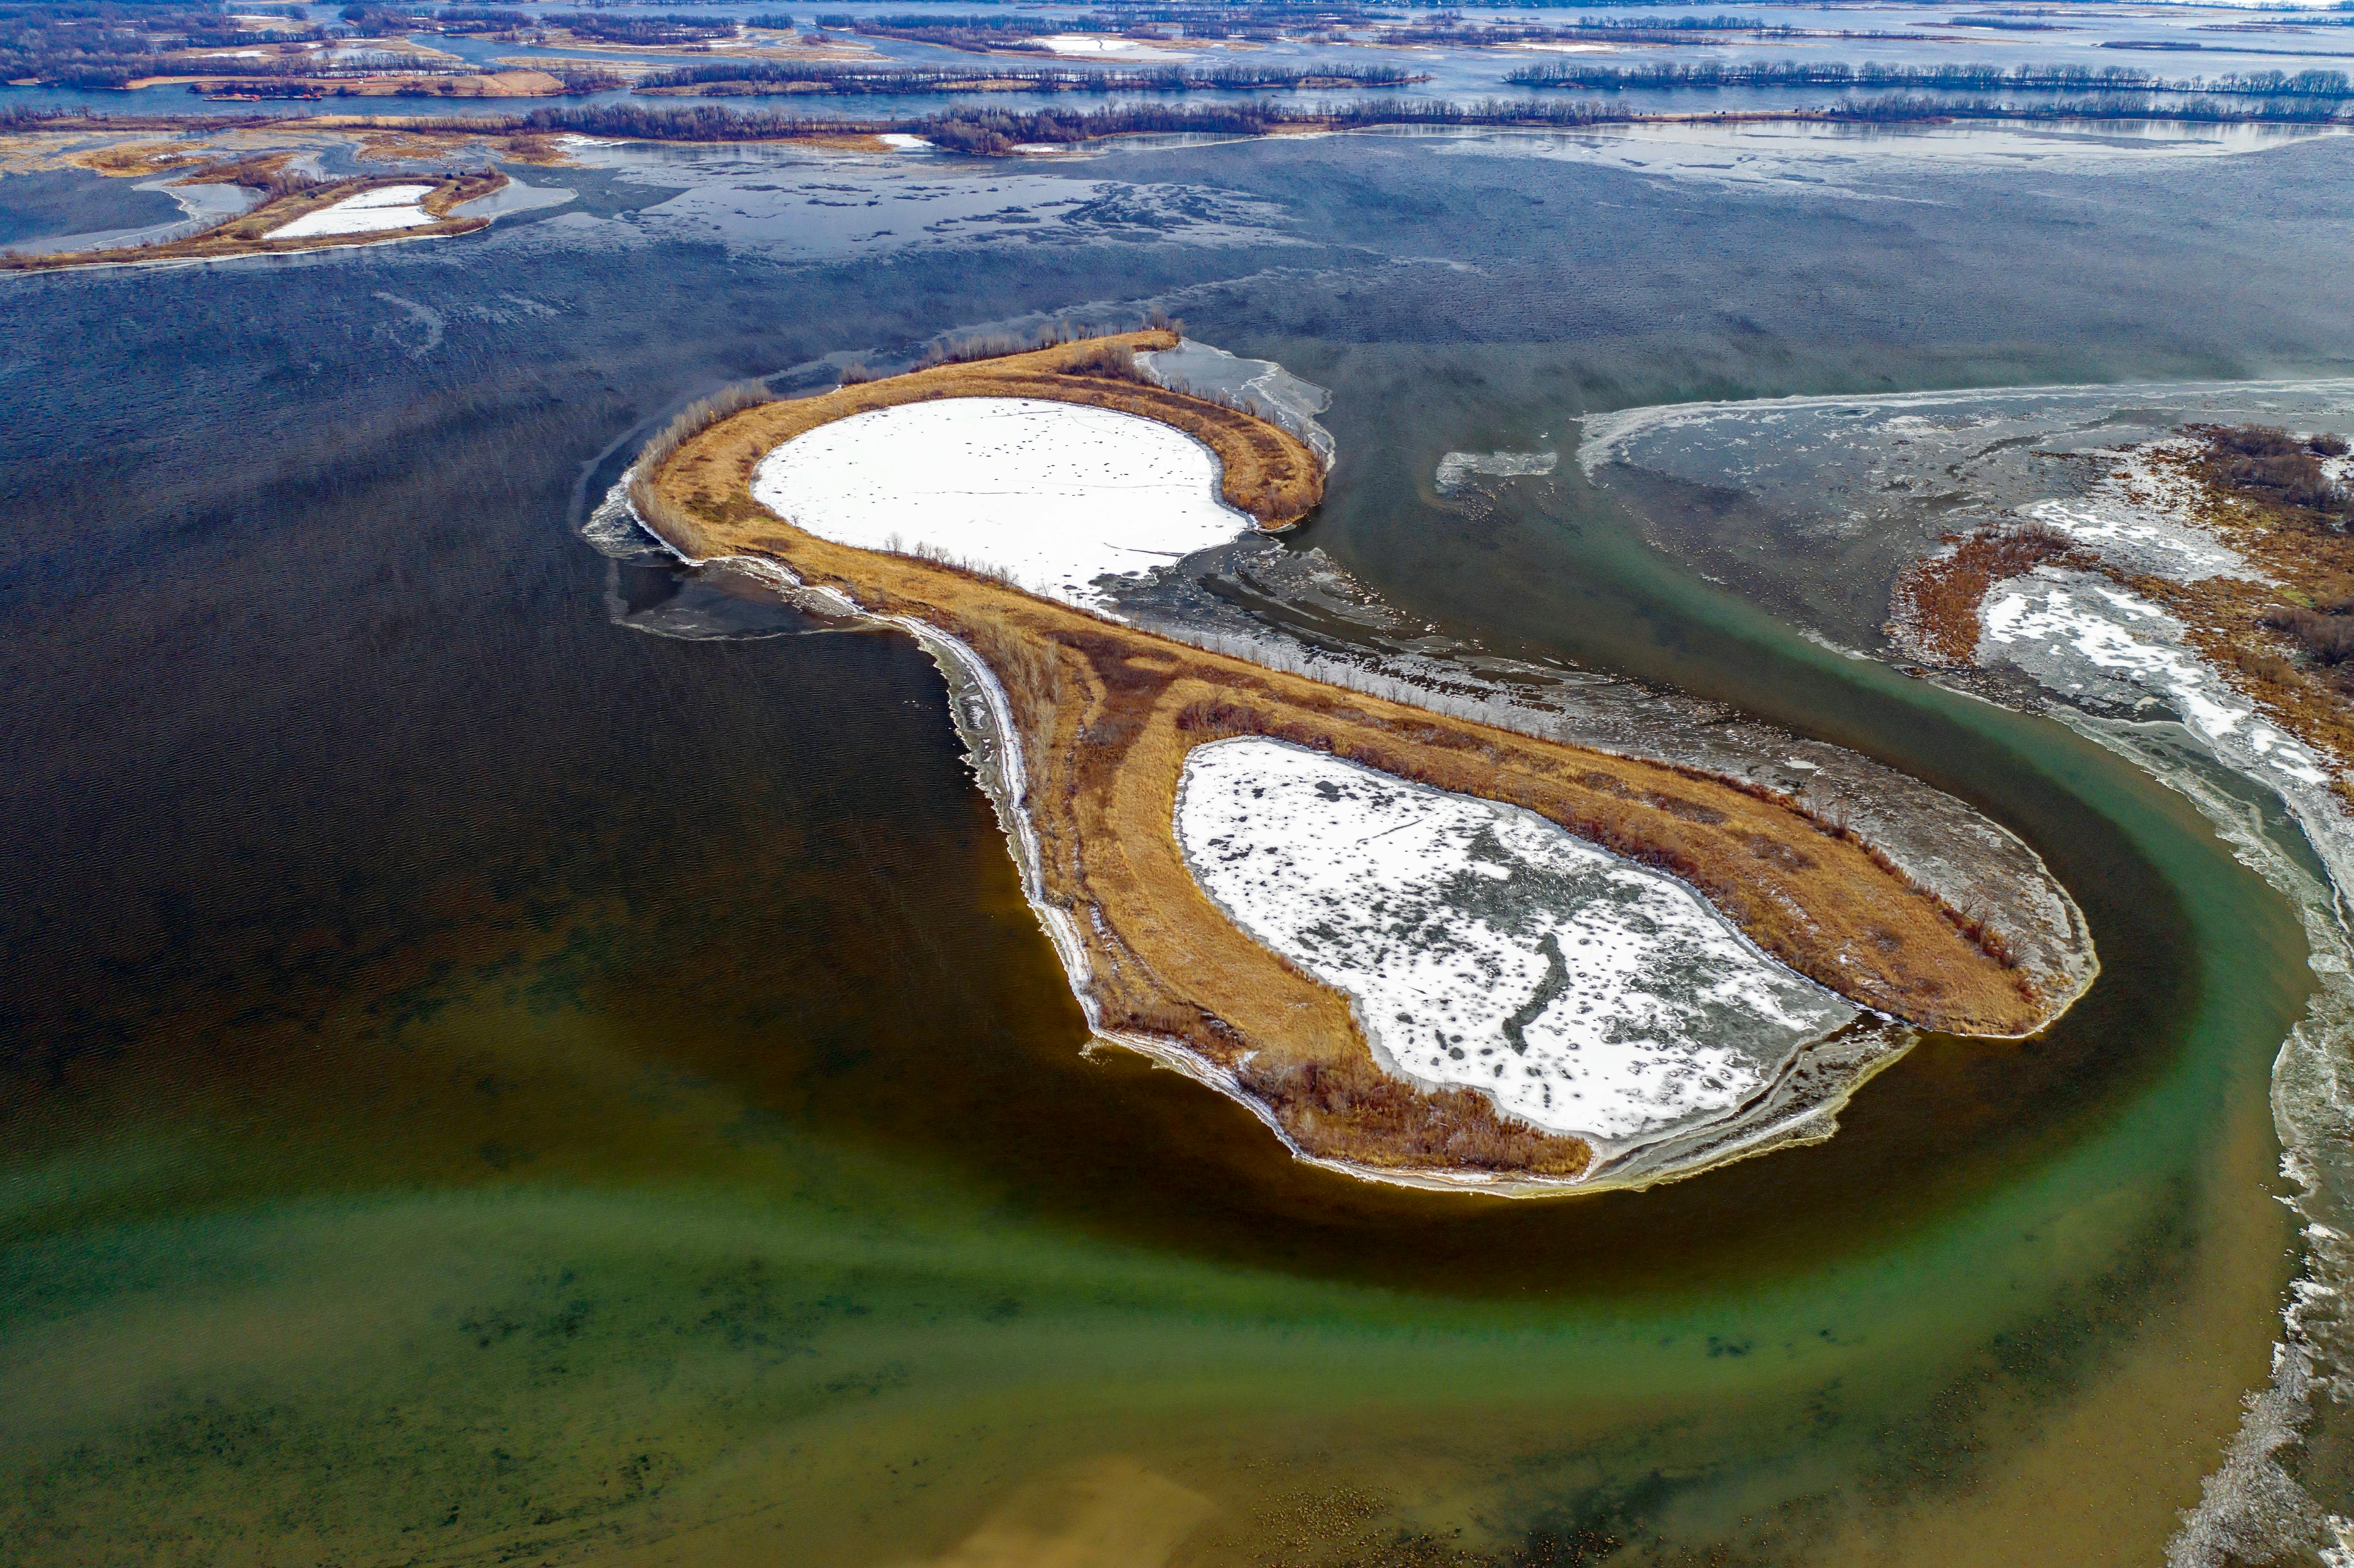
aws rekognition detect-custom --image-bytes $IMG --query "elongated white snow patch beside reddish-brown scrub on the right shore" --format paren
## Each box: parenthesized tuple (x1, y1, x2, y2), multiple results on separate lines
(1977, 572, 2330, 784)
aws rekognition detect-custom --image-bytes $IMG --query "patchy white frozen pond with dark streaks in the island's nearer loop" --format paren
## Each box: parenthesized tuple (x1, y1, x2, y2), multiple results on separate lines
(1177, 737, 1855, 1144)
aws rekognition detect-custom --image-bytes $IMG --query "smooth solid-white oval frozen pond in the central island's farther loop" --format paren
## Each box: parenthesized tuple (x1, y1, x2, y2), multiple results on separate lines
(751, 398, 1250, 610)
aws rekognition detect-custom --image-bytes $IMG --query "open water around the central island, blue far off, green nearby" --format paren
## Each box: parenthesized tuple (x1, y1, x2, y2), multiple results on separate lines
(0, 119, 2354, 1566)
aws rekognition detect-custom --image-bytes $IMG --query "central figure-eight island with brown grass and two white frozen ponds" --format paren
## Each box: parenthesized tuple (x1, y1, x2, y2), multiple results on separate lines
(626, 330, 2081, 1194)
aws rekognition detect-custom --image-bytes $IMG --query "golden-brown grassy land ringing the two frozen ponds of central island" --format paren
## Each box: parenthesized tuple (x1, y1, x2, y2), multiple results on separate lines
(631, 332, 2071, 1187)
